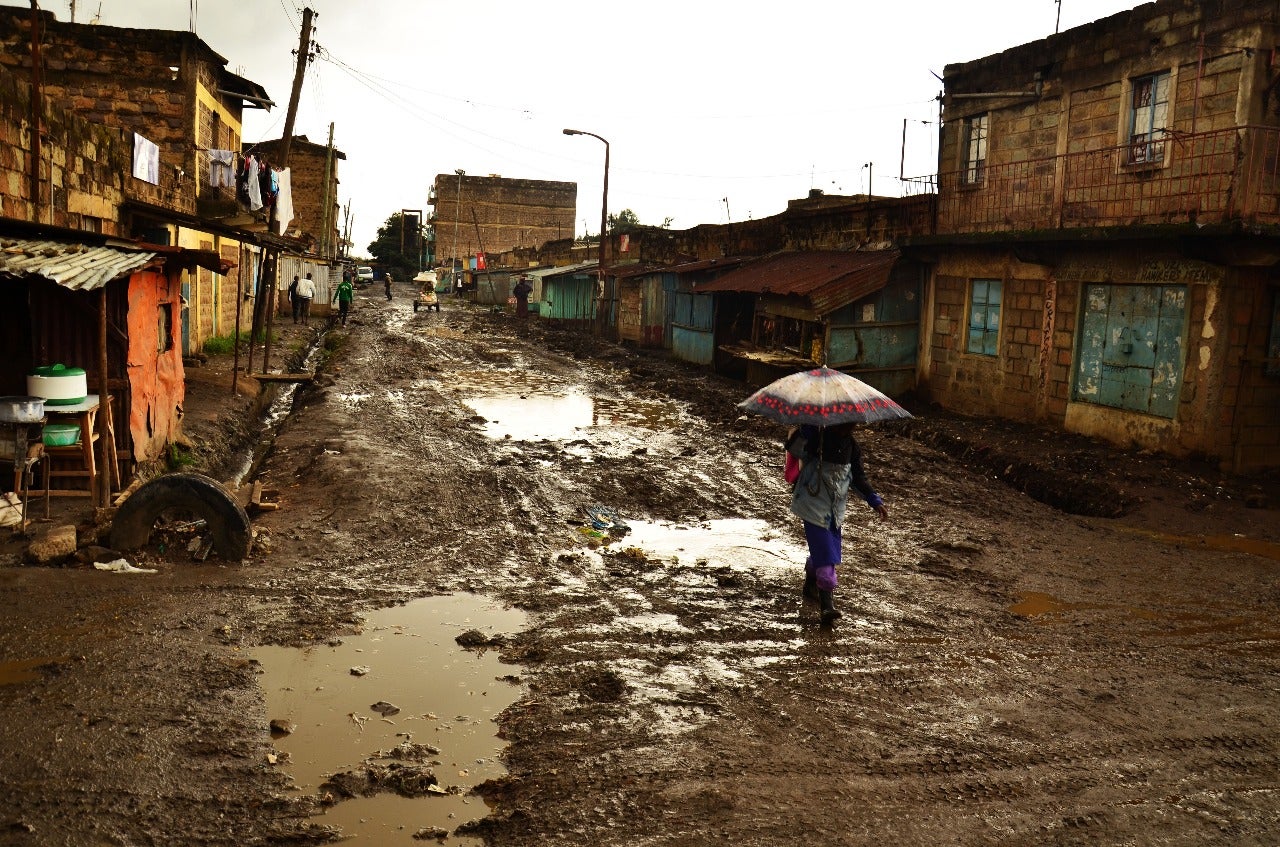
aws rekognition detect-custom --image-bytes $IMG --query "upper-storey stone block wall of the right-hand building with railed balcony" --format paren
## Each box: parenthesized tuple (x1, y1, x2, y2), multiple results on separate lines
(938, 0, 1280, 232)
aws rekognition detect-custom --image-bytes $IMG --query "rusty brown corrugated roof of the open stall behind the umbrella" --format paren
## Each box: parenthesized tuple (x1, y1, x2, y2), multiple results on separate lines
(695, 249, 901, 315)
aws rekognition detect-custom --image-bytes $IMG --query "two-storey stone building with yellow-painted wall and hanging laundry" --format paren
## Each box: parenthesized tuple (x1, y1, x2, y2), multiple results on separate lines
(0, 6, 273, 352)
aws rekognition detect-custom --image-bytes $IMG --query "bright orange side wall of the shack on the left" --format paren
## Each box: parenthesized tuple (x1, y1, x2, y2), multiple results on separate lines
(128, 271, 186, 462)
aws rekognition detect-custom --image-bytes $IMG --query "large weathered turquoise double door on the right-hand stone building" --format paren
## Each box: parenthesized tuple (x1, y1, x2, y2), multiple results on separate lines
(1073, 285, 1187, 418)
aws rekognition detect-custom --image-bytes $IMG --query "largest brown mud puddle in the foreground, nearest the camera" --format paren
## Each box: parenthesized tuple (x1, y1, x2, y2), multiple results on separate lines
(255, 595, 525, 846)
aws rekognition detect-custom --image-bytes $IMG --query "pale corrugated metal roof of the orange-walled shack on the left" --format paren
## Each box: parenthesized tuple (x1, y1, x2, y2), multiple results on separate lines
(0, 238, 156, 290)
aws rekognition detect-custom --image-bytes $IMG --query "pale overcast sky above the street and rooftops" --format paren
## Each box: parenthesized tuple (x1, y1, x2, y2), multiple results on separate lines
(49, 0, 1138, 255)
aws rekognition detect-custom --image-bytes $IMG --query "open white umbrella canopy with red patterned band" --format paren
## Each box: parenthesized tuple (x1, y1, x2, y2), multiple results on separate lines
(737, 367, 911, 426)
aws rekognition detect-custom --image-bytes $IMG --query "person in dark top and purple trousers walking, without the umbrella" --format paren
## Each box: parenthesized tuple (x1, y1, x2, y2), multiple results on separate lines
(786, 424, 888, 626)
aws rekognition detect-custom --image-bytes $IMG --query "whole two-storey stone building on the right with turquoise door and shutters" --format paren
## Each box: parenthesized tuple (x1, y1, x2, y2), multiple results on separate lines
(908, 0, 1280, 471)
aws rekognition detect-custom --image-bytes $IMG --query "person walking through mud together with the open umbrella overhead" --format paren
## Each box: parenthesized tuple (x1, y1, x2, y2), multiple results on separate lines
(739, 366, 911, 626)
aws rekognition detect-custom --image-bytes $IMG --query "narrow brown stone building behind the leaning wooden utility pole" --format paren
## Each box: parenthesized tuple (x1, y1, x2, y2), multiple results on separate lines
(246, 136, 347, 258)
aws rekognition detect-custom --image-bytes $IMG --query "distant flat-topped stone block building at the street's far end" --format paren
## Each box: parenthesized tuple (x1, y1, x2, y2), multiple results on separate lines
(428, 174, 577, 272)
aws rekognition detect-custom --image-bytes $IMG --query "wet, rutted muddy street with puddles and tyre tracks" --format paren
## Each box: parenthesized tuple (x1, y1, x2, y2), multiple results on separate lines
(0, 286, 1280, 847)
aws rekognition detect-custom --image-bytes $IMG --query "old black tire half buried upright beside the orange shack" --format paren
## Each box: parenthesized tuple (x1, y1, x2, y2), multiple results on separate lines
(111, 473, 252, 562)
